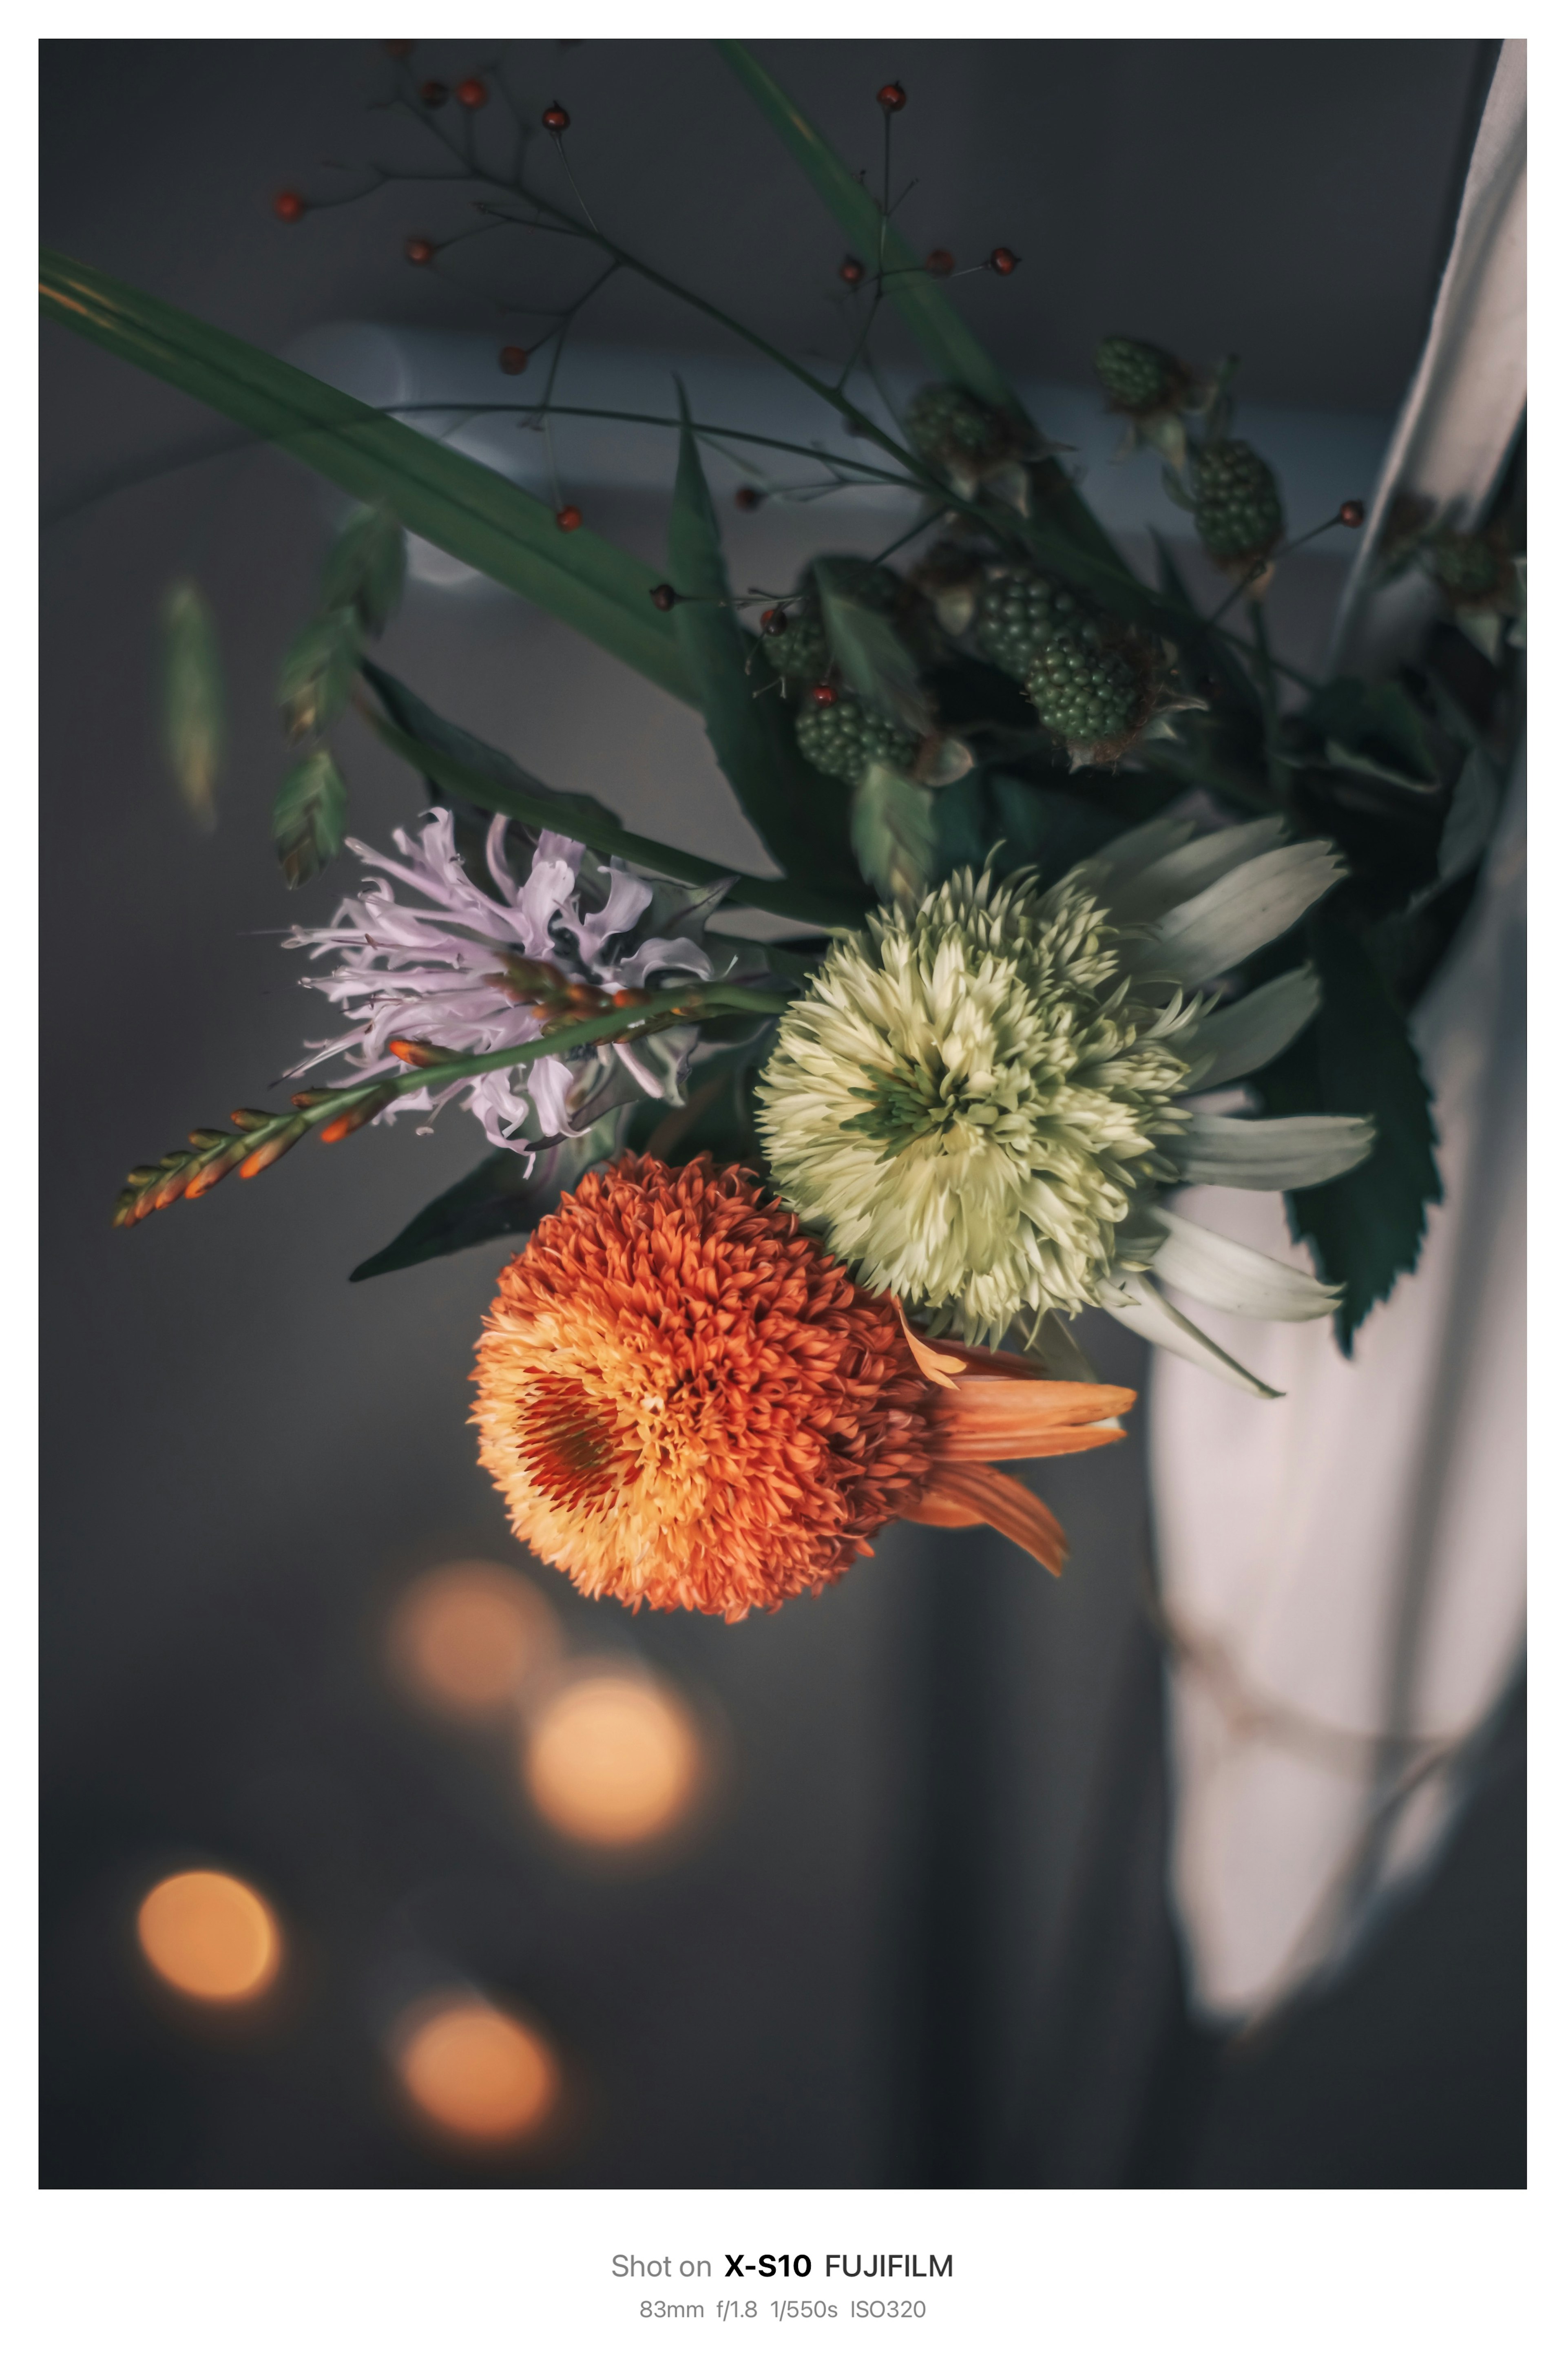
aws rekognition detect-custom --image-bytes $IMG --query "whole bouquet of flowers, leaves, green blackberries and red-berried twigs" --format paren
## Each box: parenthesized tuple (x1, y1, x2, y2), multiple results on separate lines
(43, 43, 1523, 1621)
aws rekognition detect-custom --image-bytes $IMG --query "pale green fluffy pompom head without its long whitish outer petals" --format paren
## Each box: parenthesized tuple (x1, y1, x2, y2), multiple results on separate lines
(761, 871, 1190, 1340)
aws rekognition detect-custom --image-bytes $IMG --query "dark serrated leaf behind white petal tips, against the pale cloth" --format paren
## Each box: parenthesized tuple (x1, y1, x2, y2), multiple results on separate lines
(1256, 916, 1442, 1354)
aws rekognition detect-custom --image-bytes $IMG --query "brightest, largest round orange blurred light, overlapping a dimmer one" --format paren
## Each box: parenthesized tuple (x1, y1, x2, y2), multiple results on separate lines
(521, 1673, 702, 1845)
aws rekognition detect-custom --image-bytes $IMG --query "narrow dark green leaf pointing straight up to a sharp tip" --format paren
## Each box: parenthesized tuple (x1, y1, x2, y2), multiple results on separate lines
(669, 381, 864, 916)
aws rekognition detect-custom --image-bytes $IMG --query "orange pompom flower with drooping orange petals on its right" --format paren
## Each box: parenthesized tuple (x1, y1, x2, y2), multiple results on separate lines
(473, 1157, 1133, 1621)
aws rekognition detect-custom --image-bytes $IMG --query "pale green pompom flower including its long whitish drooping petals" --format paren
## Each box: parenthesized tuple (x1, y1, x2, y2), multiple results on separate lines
(759, 821, 1371, 1388)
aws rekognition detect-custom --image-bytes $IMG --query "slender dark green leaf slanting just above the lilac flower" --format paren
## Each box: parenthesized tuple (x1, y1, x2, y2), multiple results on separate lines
(364, 664, 864, 926)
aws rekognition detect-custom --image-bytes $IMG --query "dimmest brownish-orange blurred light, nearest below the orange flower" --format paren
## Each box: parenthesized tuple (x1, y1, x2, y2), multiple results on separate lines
(393, 1561, 559, 1716)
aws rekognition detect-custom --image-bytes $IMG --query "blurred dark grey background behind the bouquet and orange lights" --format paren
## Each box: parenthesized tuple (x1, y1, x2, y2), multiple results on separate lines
(43, 40, 1513, 2187)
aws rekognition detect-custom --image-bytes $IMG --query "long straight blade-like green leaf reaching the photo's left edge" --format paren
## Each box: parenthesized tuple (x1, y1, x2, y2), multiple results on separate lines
(40, 248, 695, 702)
